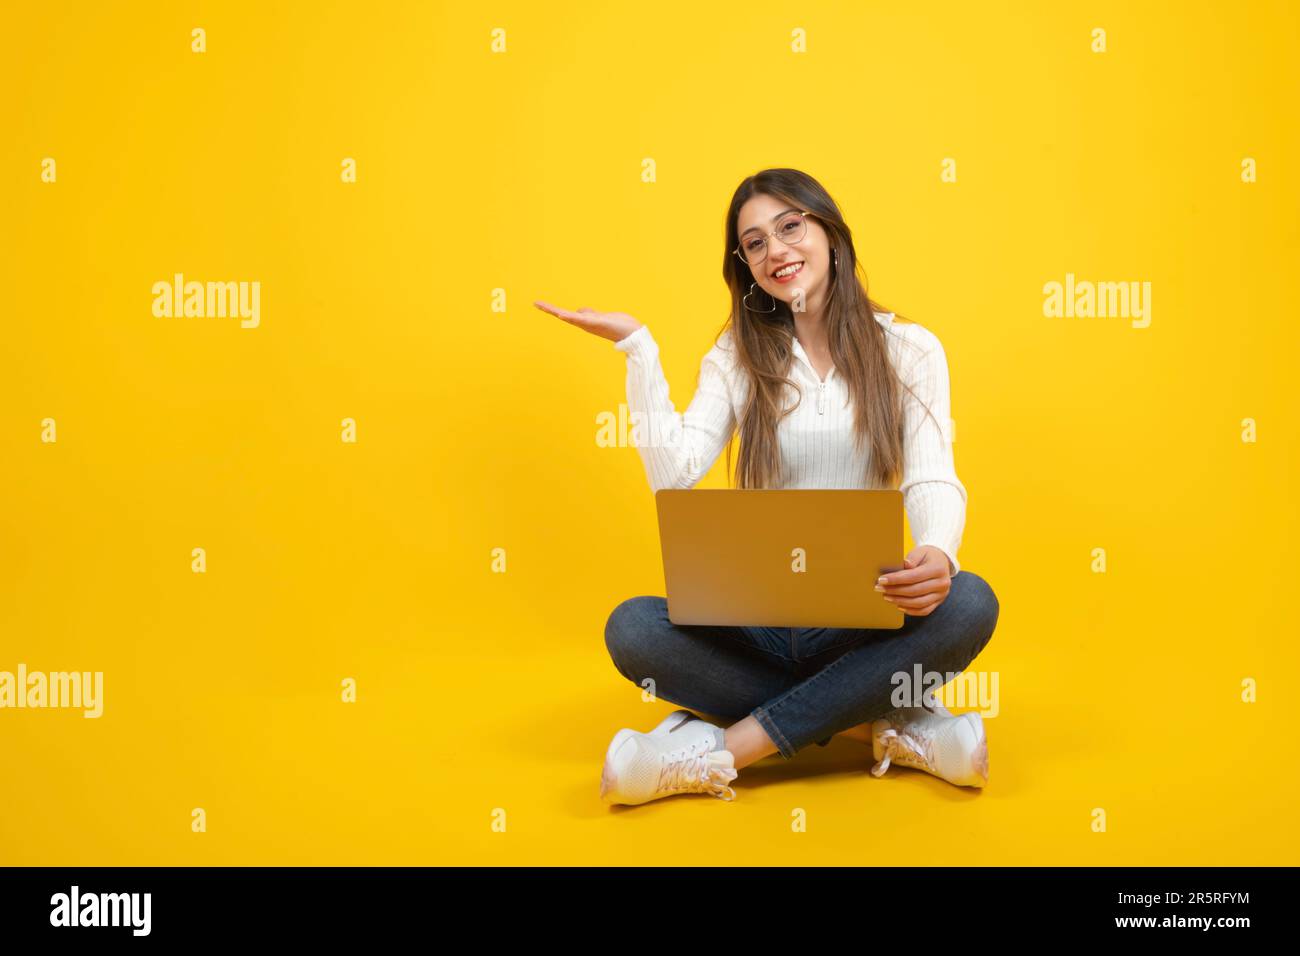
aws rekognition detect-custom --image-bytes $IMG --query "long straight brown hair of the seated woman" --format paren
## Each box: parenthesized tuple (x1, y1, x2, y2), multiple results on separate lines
(718, 169, 930, 488)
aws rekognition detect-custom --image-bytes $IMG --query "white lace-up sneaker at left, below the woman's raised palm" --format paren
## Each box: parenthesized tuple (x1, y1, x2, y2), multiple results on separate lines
(601, 711, 736, 804)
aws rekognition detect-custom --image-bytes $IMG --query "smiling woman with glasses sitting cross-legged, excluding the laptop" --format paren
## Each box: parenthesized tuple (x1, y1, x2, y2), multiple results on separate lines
(534, 169, 998, 804)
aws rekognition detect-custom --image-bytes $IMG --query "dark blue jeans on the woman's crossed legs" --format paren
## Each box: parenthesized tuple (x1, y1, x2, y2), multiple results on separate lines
(605, 568, 998, 760)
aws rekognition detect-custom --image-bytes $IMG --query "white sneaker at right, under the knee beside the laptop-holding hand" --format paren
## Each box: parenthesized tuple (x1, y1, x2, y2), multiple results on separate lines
(871, 700, 988, 787)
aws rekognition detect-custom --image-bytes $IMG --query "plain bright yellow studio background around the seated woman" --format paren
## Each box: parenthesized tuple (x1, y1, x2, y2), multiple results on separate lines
(0, 1, 1300, 865)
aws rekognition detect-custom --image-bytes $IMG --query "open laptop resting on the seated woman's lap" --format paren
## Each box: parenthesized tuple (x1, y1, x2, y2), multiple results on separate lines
(655, 488, 904, 630)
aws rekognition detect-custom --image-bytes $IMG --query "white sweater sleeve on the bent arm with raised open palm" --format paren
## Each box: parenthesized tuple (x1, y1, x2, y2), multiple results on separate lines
(614, 325, 736, 492)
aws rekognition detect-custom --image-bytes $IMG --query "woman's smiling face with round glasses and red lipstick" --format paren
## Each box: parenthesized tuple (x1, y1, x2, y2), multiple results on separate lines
(737, 193, 831, 307)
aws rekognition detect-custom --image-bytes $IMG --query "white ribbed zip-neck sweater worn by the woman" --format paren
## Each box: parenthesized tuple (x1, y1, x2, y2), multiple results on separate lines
(614, 312, 966, 575)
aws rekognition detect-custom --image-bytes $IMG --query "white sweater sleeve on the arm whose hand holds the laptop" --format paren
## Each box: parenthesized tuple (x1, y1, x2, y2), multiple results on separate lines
(898, 338, 966, 575)
